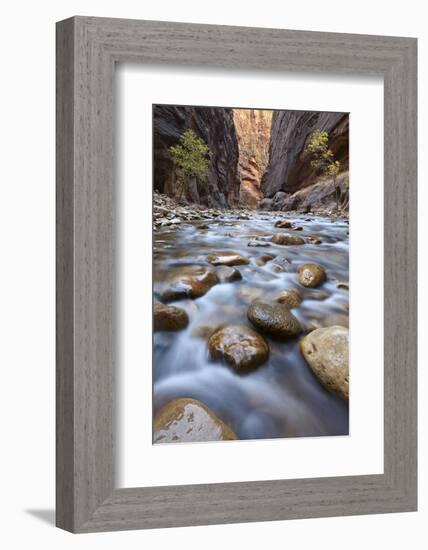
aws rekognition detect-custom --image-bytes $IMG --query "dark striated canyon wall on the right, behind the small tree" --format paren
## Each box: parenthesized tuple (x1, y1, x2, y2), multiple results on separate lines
(261, 111, 349, 198)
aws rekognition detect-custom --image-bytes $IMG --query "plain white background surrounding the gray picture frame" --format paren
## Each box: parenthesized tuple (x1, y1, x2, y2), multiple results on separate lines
(0, 0, 428, 550)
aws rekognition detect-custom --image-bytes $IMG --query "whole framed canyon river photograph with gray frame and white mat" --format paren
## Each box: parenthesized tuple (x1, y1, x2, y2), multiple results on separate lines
(57, 17, 417, 533)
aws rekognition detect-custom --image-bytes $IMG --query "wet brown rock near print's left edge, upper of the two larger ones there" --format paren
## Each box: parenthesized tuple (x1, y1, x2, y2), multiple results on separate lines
(155, 266, 219, 301)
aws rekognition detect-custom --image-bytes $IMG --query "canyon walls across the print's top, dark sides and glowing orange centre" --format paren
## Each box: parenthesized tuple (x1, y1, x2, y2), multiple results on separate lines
(153, 105, 349, 211)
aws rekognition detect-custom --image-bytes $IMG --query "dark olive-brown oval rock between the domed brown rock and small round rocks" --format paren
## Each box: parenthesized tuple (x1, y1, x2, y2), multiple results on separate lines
(247, 300, 302, 339)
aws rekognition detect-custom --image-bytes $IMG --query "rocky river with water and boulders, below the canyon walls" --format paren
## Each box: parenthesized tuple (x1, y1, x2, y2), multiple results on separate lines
(153, 194, 349, 443)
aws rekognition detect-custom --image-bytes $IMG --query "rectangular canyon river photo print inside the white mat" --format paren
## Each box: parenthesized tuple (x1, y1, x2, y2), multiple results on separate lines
(153, 105, 352, 444)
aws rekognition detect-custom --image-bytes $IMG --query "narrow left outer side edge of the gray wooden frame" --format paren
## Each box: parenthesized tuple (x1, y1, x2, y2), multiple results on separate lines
(56, 18, 75, 530)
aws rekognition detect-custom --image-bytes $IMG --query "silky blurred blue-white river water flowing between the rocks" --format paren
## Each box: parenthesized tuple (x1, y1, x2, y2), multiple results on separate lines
(153, 213, 349, 439)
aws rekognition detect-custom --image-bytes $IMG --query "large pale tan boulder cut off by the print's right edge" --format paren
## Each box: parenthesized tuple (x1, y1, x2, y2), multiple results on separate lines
(300, 326, 349, 400)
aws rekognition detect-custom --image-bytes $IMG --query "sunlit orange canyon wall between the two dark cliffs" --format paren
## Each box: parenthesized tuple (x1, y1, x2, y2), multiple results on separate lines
(233, 109, 272, 208)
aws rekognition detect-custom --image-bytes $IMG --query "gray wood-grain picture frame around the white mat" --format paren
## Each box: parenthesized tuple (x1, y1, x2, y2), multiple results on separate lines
(56, 17, 417, 533)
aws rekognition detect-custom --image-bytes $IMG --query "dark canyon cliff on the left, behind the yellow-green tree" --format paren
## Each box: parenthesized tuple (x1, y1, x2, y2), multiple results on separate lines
(153, 105, 240, 208)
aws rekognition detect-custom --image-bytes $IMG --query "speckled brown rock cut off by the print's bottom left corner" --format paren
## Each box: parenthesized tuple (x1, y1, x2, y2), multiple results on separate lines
(153, 398, 238, 443)
